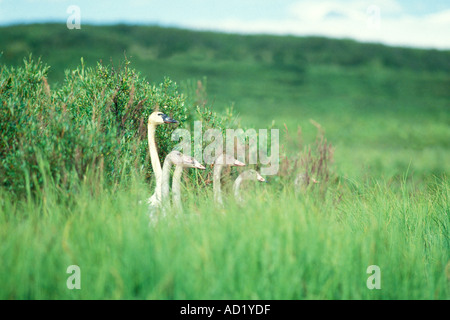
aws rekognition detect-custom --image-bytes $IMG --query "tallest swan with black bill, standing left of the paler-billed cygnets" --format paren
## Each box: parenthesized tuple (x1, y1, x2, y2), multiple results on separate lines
(147, 111, 178, 207)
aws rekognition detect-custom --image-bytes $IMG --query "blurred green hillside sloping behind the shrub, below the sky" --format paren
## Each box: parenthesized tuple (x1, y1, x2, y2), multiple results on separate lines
(0, 24, 450, 178)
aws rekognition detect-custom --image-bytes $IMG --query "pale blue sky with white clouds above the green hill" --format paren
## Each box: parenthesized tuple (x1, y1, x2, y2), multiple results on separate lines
(0, 0, 450, 49)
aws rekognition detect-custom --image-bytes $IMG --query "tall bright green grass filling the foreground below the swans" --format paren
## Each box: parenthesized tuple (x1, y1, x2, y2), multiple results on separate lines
(0, 174, 449, 299)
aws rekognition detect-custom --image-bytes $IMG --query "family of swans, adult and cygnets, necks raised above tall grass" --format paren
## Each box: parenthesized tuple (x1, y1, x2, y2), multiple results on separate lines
(147, 110, 265, 212)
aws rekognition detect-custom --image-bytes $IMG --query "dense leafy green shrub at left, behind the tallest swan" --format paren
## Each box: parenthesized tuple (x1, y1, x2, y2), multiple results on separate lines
(0, 57, 229, 199)
